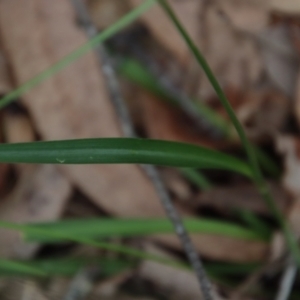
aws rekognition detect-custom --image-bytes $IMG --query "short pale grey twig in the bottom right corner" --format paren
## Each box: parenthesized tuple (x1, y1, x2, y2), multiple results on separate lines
(276, 258, 297, 300)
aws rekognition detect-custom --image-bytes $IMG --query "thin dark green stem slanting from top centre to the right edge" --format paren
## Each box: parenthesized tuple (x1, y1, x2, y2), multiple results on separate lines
(157, 0, 300, 266)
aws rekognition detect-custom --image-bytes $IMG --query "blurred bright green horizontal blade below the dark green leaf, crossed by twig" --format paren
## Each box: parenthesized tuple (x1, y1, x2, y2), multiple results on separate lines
(0, 218, 267, 243)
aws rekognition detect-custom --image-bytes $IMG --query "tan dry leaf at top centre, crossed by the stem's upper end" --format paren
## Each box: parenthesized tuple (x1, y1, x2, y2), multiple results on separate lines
(129, 0, 203, 64)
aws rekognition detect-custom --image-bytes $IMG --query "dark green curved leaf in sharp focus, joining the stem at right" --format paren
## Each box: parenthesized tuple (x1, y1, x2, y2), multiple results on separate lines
(0, 138, 252, 177)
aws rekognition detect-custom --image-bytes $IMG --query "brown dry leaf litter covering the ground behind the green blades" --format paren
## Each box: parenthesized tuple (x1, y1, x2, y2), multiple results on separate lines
(0, 0, 300, 300)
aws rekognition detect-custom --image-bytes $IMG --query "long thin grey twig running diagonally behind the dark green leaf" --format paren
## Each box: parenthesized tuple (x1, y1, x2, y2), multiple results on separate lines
(72, 0, 213, 300)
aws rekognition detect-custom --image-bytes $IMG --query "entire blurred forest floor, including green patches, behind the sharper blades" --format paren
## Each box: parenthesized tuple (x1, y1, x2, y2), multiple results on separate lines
(0, 0, 300, 300)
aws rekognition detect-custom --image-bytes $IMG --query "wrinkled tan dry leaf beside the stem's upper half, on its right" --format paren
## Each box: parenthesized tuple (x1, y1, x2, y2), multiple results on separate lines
(199, 1, 262, 99)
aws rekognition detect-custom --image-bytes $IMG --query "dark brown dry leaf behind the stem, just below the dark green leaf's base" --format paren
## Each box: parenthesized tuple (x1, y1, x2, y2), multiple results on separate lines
(190, 183, 291, 215)
